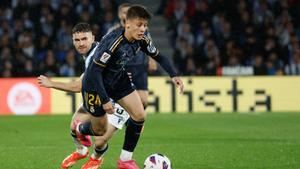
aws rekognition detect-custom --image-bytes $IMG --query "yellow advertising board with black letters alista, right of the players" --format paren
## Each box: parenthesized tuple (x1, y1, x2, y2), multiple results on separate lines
(54, 77, 300, 113)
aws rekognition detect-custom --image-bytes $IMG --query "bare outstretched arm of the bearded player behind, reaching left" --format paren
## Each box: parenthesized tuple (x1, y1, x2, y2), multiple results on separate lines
(37, 74, 83, 93)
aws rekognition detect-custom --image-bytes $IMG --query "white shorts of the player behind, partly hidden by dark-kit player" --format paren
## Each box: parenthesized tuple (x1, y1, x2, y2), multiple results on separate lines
(107, 103, 130, 129)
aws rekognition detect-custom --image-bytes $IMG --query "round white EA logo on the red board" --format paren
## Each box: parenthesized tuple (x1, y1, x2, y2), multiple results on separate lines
(7, 82, 42, 115)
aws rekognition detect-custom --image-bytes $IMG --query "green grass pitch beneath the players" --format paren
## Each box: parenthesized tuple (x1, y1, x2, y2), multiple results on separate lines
(0, 113, 300, 169)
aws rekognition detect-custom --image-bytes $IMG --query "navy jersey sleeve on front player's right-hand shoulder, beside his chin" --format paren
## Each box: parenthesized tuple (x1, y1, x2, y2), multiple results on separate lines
(141, 32, 159, 57)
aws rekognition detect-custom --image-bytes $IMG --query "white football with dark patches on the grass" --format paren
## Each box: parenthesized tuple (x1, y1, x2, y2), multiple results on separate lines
(144, 153, 171, 169)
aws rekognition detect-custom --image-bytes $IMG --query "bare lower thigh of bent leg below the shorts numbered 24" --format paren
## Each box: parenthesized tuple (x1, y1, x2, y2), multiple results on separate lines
(91, 114, 107, 136)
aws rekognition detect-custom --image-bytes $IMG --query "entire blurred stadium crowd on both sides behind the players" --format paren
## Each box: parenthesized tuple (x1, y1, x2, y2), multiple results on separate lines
(0, 0, 300, 77)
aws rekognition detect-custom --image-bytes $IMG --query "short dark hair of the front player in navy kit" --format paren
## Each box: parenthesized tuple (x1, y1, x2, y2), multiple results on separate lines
(126, 5, 151, 20)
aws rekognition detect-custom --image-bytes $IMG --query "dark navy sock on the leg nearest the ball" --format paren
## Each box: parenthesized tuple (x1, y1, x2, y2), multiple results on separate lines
(123, 118, 144, 152)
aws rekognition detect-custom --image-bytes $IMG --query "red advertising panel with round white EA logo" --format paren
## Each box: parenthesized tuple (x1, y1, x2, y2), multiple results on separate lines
(0, 78, 51, 115)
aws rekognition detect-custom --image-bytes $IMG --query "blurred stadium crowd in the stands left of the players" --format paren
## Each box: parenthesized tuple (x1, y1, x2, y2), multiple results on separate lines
(0, 0, 121, 77)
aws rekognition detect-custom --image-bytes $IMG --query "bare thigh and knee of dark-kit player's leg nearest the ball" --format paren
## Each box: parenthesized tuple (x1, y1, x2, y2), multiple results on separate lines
(118, 91, 146, 121)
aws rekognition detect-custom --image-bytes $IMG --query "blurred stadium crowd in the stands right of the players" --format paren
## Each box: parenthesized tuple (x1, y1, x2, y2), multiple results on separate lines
(159, 0, 300, 75)
